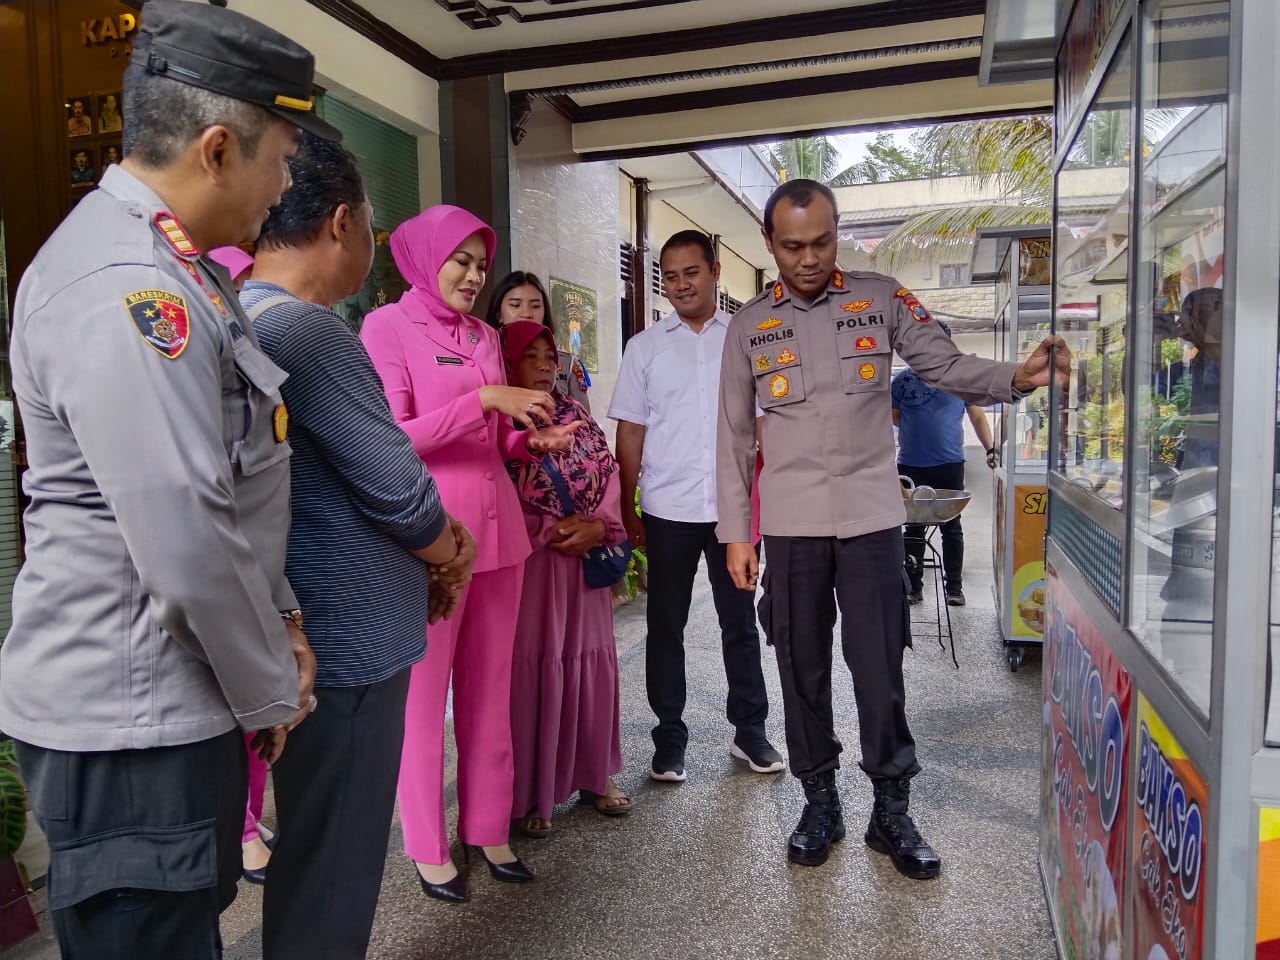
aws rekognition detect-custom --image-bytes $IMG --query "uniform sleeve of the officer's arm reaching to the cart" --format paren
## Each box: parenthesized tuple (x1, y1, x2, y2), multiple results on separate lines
(890, 282, 1019, 403)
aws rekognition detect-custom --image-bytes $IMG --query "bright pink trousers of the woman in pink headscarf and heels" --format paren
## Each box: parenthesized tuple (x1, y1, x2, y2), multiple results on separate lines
(398, 564, 524, 864)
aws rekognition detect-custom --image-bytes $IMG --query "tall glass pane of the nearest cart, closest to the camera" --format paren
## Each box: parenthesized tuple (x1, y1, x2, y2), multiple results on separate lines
(1129, 0, 1228, 717)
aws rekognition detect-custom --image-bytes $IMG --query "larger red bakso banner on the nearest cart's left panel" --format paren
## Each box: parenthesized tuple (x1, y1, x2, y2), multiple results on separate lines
(1041, 564, 1133, 960)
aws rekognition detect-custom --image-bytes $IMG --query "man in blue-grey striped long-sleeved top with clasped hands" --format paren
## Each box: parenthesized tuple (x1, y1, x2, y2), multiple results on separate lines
(241, 136, 475, 960)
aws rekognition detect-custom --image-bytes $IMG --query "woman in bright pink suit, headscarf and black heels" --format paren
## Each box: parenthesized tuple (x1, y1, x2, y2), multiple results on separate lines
(361, 205, 575, 902)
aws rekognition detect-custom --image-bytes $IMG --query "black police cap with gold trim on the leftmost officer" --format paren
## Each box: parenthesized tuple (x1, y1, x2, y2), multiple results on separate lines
(133, 0, 342, 141)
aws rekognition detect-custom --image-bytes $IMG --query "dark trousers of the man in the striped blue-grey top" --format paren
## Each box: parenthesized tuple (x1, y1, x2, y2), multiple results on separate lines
(263, 668, 410, 960)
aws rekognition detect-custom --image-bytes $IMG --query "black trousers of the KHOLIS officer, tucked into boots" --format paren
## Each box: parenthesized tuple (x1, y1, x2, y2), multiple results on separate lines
(760, 527, 920, 780)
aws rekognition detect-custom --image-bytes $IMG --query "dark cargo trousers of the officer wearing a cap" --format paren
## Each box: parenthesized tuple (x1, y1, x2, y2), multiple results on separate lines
(18, 730, 248, 960)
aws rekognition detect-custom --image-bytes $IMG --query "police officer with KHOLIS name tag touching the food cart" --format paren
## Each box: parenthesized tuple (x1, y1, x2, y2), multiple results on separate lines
(716, 179, 1070, 879)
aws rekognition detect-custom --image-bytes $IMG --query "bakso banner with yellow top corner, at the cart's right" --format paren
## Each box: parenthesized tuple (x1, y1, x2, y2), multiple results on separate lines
(1130, 694, 1208, 960)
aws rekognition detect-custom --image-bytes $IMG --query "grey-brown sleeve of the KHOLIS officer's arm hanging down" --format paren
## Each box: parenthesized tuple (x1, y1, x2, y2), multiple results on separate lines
(716, 316, 756, 543)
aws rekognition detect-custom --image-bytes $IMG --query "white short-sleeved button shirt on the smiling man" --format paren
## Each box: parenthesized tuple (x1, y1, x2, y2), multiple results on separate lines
(609, 310, 728, 524)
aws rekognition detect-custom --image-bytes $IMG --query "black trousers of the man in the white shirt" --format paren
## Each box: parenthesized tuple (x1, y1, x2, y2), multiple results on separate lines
(644, 515, 769, 750)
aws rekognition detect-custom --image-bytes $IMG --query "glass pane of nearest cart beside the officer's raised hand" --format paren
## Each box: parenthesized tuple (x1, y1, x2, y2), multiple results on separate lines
(1053, 40, 1133, 508)
